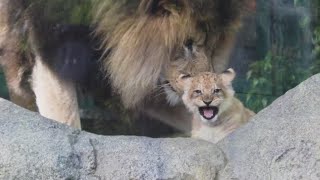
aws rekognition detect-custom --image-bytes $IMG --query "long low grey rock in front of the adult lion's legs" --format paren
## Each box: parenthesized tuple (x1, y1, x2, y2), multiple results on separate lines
(0, 99, 226, 180)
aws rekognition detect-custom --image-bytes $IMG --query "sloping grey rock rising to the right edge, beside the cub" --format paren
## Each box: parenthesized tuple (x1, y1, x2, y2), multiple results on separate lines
(219, 74, 320, 180)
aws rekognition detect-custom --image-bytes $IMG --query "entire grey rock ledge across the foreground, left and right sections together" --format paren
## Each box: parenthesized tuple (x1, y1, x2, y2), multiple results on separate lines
(0, 74, 320, 180)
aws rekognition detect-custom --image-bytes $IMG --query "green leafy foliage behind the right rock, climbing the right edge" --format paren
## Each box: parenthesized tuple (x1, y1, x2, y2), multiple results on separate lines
(245, 24, 320, 112)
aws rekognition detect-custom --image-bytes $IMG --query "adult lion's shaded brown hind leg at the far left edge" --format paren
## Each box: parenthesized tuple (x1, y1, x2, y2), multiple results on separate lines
(0, 0, 37, 111)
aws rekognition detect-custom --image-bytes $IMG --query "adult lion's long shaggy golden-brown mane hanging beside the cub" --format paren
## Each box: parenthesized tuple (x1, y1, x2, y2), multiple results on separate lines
(93, 0, 250, 108)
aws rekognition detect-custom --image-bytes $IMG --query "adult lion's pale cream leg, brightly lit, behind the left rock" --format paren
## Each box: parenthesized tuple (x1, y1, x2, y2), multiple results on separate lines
(32, 56, 81, 129)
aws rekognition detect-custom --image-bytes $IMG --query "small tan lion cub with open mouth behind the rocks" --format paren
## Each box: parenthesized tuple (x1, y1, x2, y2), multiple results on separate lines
(180, 68, 255, 143)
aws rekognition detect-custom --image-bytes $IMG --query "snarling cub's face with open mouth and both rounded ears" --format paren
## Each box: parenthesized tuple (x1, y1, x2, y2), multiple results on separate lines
(180, 69, 235, 122)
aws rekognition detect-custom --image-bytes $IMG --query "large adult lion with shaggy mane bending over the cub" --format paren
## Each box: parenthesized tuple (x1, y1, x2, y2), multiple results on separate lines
(0, 0, 253, 129)
